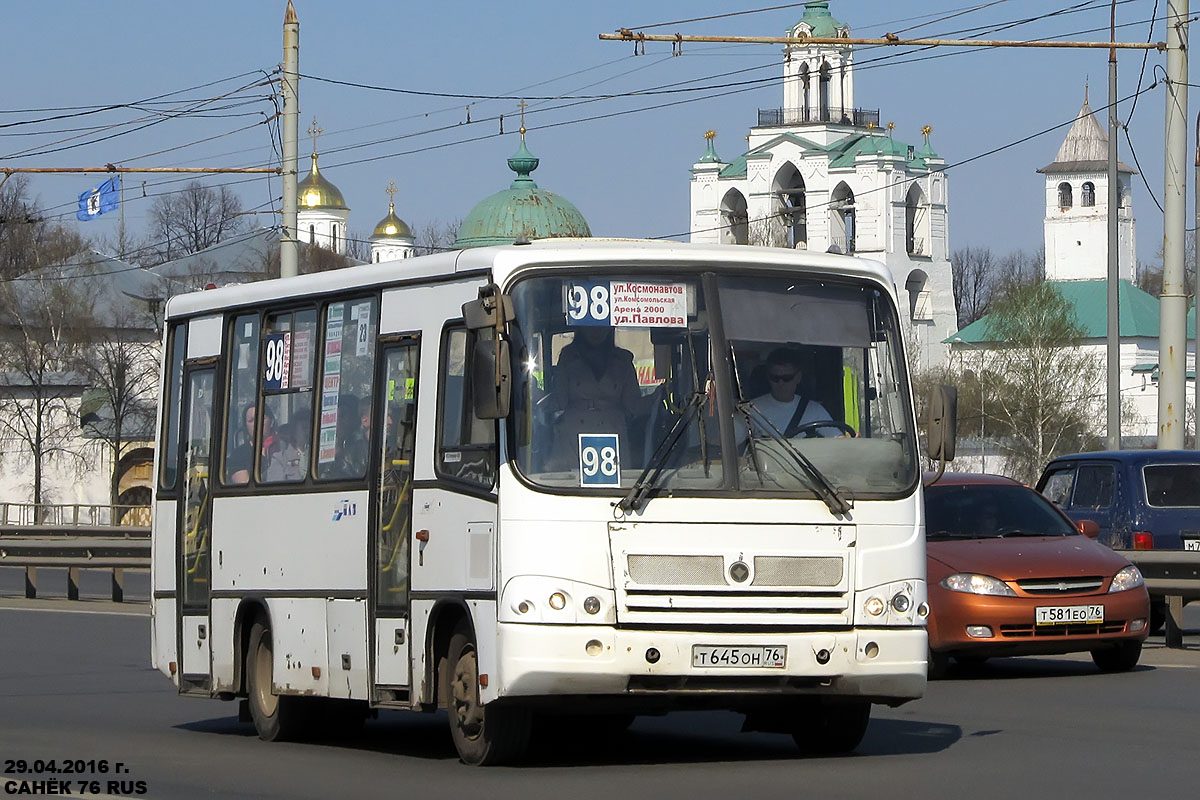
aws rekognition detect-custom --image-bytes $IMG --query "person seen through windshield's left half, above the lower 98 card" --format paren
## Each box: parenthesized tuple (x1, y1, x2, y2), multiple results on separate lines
(554, 326, 662, 468)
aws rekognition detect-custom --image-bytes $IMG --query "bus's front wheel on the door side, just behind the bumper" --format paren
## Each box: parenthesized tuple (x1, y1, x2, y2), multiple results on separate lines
(444, 626, 530, 766)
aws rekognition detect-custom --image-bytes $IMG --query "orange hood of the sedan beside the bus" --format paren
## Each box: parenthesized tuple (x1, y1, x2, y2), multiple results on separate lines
(926, 536, 1129, 581)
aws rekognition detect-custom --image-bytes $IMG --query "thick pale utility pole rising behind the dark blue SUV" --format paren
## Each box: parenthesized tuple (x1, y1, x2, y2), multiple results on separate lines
(1158, 0, 1188, 450)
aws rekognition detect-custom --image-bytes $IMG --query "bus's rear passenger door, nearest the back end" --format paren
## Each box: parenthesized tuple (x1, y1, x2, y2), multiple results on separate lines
(176, 366, 215, 696)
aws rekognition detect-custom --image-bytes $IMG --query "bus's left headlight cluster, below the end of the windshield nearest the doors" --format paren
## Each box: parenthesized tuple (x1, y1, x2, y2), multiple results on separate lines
(498, 575, 617, 625)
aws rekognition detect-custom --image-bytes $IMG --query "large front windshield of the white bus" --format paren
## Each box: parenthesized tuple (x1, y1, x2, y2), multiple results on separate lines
(509, 269, 917, 498)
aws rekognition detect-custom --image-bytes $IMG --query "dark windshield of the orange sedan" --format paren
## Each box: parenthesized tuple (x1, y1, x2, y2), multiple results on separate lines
(925, 483, 1079, 541)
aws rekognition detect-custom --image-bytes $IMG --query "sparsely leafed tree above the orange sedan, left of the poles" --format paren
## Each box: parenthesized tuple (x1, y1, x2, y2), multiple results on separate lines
(979, 283, 1104, 482)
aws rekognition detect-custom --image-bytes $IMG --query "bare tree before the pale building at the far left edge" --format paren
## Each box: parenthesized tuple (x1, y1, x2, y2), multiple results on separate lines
(0, 269, 92, 504)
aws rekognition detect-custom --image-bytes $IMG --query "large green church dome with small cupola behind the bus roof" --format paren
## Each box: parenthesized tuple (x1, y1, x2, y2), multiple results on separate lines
(454, 136, 592, 248)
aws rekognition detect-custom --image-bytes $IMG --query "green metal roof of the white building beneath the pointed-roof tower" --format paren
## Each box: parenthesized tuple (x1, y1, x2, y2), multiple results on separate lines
(942, 281, 1195, 344)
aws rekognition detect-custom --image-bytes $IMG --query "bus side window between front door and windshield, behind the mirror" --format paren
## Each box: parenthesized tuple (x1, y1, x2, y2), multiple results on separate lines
(437, 326, 497, 488)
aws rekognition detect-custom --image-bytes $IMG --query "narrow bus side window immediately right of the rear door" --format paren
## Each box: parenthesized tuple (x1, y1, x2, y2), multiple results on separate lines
(221, 314, 258, 486)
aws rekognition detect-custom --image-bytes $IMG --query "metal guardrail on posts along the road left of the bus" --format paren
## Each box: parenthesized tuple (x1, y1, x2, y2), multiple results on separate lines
(0, 513, 150, 603)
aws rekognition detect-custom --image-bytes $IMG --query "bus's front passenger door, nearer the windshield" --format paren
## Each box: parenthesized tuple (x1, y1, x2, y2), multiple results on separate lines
(372, 336, 420, 687)
